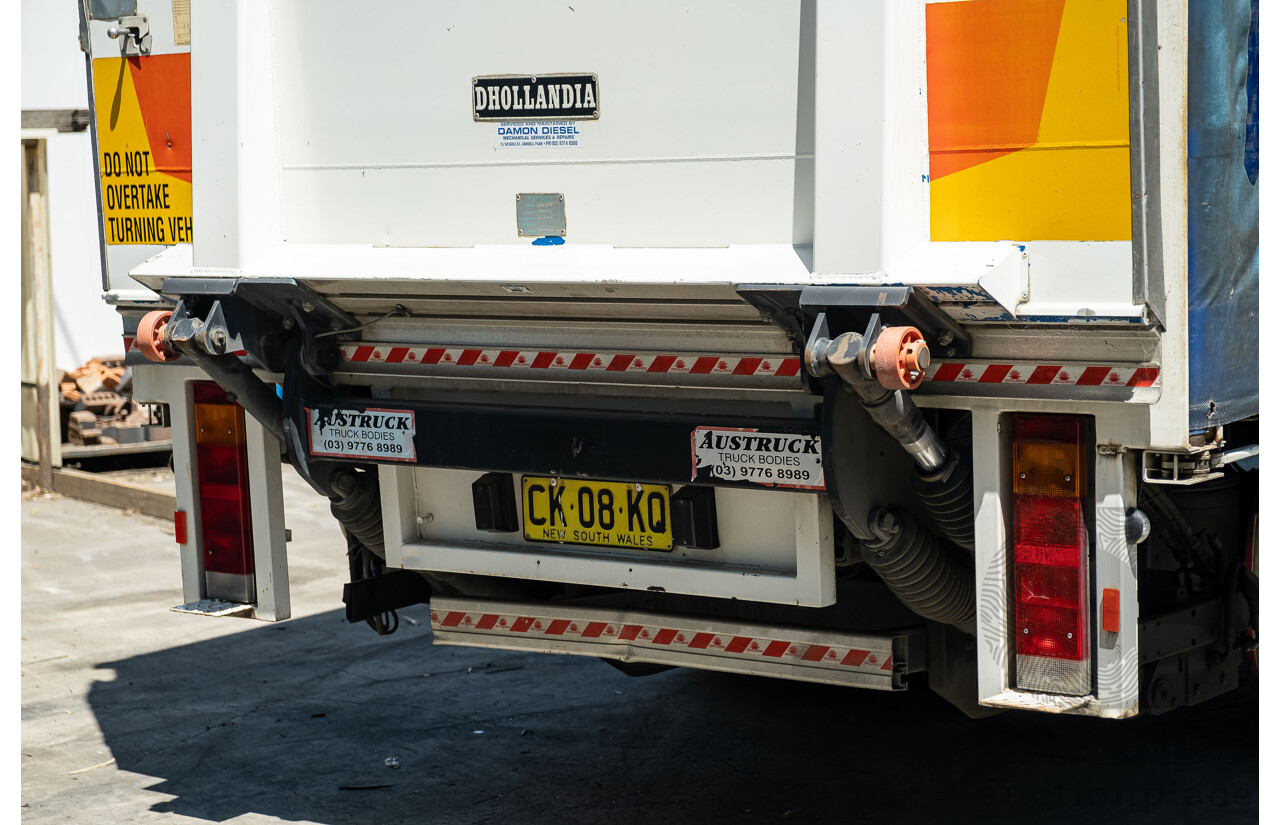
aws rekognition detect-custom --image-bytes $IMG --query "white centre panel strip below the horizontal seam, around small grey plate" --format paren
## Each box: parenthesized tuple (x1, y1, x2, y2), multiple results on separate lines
(284, 159, 796, 247)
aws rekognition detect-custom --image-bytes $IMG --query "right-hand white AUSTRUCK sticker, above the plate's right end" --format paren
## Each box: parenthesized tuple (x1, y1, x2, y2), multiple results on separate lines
(690, 427, 827, 490)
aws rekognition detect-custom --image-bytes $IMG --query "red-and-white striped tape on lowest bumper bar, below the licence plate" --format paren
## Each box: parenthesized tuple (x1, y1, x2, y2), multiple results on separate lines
(431, 610, 893, 672)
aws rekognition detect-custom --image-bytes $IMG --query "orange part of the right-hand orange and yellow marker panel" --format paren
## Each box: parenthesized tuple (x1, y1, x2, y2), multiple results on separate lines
(924, 0, 1066, 180)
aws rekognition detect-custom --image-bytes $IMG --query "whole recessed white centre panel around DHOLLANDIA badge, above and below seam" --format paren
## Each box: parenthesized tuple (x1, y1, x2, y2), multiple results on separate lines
(275, 0, 810, 247)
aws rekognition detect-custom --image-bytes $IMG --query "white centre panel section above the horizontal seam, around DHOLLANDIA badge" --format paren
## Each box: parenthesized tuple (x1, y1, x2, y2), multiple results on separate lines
(275, 0, 800, 168)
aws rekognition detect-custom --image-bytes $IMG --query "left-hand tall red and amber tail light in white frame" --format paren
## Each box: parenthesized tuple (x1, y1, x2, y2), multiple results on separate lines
(192, 381, 255, 602)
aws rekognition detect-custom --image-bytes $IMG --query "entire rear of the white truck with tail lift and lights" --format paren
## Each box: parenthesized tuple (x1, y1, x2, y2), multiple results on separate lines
(82, 0, 1258, 718)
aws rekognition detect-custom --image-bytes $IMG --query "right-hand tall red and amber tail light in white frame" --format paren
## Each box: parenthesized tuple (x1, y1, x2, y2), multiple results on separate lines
(1012, 414, 1092, 696)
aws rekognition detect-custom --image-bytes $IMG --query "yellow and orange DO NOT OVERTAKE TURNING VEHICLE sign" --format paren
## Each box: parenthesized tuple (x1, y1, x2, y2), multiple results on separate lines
(93, 54, 192, 244)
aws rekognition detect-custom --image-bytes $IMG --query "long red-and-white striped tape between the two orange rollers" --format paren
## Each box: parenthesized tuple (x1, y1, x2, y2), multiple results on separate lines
(342, 344, 800, 379)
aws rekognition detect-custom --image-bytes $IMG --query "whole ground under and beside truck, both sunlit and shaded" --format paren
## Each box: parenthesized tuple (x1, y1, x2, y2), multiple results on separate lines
(20, 471, 1258, 825)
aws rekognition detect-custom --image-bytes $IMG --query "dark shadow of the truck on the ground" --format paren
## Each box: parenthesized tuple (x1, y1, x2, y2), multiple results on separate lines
(90, 608, 1258, 825)
